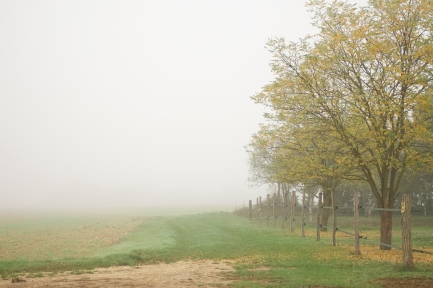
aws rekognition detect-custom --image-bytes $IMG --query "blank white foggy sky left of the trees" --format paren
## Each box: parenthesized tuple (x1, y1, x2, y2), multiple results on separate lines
(0, 0, 366, 208)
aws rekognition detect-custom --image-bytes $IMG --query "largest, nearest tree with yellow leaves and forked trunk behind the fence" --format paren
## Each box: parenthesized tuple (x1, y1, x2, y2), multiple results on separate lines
(253, 0, 433, 249)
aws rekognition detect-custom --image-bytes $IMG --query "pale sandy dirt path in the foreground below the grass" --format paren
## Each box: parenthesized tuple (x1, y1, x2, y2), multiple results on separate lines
(0, 261, 234, 288)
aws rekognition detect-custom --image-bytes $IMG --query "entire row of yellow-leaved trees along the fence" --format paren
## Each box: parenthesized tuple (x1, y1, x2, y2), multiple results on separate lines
(247, 0, 433, 249)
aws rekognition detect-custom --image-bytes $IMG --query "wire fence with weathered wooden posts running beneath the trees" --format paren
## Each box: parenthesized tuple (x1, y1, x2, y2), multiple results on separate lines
(235, 193, 433, 266)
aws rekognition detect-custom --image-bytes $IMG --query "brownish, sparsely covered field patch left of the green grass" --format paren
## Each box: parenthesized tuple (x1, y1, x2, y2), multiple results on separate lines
(0, 211, 147, 261)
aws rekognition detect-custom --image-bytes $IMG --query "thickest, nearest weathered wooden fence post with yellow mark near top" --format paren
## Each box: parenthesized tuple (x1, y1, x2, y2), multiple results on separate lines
(401, 194, 413, 268)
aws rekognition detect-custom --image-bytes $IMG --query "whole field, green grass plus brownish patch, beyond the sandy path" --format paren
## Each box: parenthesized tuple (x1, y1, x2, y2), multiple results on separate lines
(0, 209, 433, 287)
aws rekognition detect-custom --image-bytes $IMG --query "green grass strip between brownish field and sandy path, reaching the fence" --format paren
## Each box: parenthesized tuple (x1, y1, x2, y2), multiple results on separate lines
(0, 208, 433, 287)
